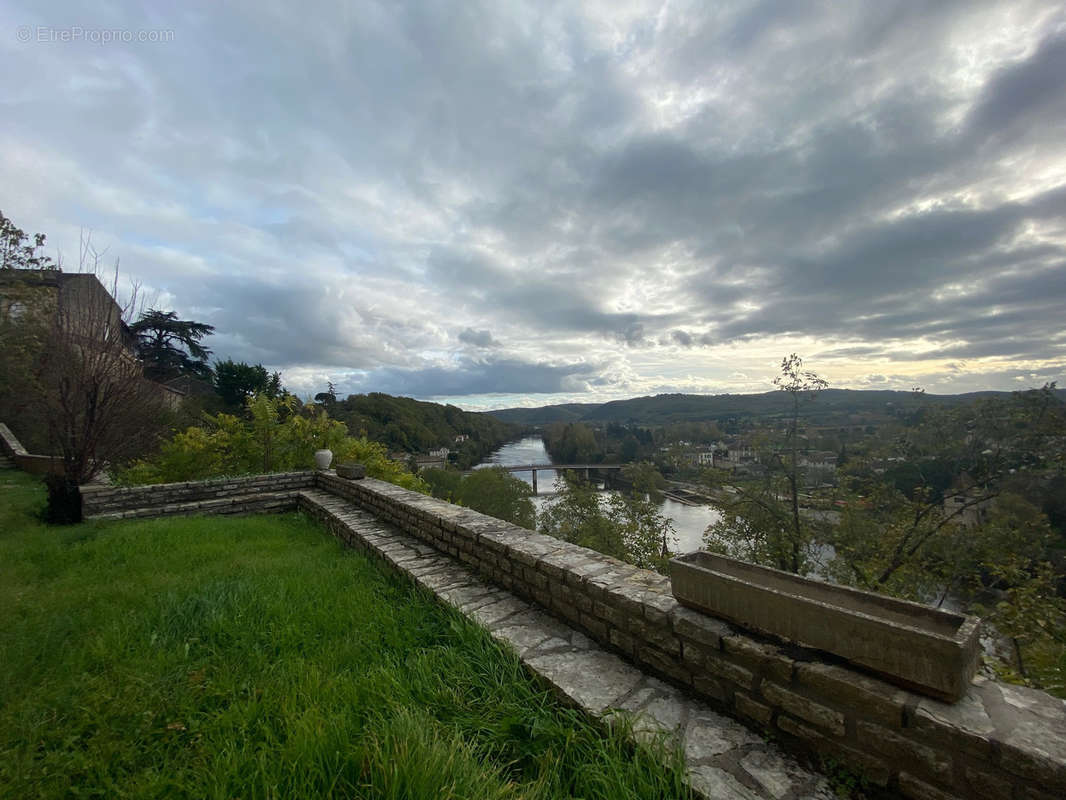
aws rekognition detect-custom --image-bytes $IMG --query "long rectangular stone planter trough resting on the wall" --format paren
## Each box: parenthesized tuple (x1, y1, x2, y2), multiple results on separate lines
(671, 551, 980, 702)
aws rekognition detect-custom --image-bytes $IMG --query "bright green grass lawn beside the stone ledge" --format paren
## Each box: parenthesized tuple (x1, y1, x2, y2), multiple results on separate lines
(0, 471, 687, 800)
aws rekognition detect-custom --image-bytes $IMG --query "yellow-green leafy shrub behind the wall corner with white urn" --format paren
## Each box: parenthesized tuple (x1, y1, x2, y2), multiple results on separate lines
(120, 395, 427, 492)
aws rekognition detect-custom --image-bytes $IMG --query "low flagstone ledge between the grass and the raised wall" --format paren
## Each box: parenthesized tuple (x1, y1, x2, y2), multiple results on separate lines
(301, 490, 834, 800)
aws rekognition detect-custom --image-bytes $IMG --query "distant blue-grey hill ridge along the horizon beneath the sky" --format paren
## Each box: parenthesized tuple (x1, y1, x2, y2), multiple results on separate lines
(489, 389, 1066, 427)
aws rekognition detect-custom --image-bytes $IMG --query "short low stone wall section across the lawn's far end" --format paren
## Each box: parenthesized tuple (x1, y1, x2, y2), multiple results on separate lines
(81, 470, 314, 519)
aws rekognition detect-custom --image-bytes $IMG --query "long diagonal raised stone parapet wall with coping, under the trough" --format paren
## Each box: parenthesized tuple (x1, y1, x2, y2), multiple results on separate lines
(77, 471, 1066, 800)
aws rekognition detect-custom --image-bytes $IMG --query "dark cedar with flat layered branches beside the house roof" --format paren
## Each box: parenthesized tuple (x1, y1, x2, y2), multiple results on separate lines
(129, 309, 214, 380)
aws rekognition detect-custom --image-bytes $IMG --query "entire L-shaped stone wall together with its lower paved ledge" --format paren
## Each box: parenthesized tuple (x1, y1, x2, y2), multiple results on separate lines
(82, 471, 1066, 800)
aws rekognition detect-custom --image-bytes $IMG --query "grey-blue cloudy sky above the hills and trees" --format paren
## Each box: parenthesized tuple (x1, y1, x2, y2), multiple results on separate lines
(0, 0, 1066, 409)
